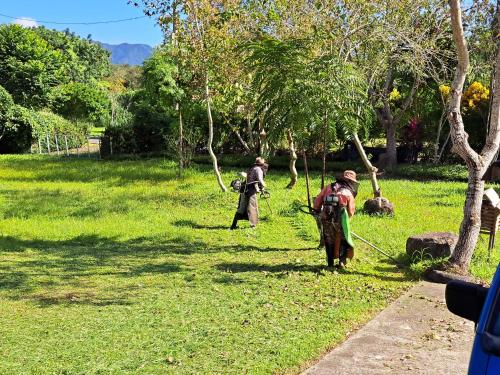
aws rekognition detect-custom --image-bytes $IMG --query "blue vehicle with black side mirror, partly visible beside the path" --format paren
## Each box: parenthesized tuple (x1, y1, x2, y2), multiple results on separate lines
(446, 265, 500, 375)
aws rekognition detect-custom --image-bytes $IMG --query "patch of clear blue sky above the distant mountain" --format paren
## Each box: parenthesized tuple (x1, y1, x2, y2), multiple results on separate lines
(0, 0, 163, 47)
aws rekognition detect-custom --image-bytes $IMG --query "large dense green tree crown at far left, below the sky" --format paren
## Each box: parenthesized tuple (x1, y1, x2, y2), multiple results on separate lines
(0, 25, 109, 108)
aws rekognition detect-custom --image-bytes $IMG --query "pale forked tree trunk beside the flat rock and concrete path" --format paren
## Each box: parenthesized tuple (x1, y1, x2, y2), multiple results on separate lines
(448, 0, 500, 271)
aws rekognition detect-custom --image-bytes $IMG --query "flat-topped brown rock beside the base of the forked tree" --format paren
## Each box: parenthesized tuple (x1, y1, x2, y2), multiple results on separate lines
(406, 232, 458, 258)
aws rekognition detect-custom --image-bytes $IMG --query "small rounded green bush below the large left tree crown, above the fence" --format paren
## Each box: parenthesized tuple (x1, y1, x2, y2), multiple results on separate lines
(51, 82, 111, 126)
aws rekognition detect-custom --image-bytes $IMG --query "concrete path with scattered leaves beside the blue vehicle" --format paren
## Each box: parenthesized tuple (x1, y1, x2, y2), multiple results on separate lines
(303, 282, 474, 375)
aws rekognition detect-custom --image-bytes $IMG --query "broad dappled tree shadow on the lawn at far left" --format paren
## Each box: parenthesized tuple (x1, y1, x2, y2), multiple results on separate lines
(0, 235, 300, 305)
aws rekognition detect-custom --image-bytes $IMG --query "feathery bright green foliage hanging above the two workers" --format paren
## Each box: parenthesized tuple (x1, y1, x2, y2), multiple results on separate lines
(246, 38, 371, 148)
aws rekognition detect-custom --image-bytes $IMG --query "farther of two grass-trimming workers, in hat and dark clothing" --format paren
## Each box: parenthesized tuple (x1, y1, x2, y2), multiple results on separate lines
(231, 157, 269, 229)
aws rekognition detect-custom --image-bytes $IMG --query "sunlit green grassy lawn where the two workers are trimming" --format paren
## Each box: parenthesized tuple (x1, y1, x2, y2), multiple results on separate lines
(0, 156, 499, 374)
